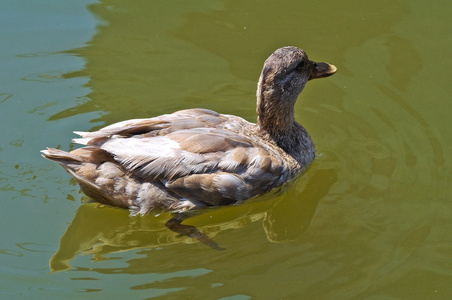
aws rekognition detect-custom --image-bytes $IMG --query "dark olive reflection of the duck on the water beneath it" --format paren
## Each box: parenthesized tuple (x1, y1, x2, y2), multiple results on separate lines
(49, 168, 337, 272)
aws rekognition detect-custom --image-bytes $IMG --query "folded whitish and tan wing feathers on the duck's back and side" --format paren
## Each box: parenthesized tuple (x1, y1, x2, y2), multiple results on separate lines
(75, 109, 285, 205)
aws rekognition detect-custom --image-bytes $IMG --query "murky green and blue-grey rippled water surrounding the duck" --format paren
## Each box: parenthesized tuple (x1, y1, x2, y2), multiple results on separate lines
(0, 0, 452, 300)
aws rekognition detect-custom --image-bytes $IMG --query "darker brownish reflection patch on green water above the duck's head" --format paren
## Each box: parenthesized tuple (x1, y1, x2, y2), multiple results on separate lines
(174, 0, 407, 80)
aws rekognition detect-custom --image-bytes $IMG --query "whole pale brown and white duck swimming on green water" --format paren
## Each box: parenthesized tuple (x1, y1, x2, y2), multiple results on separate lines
(41, 46, 337, 250)
